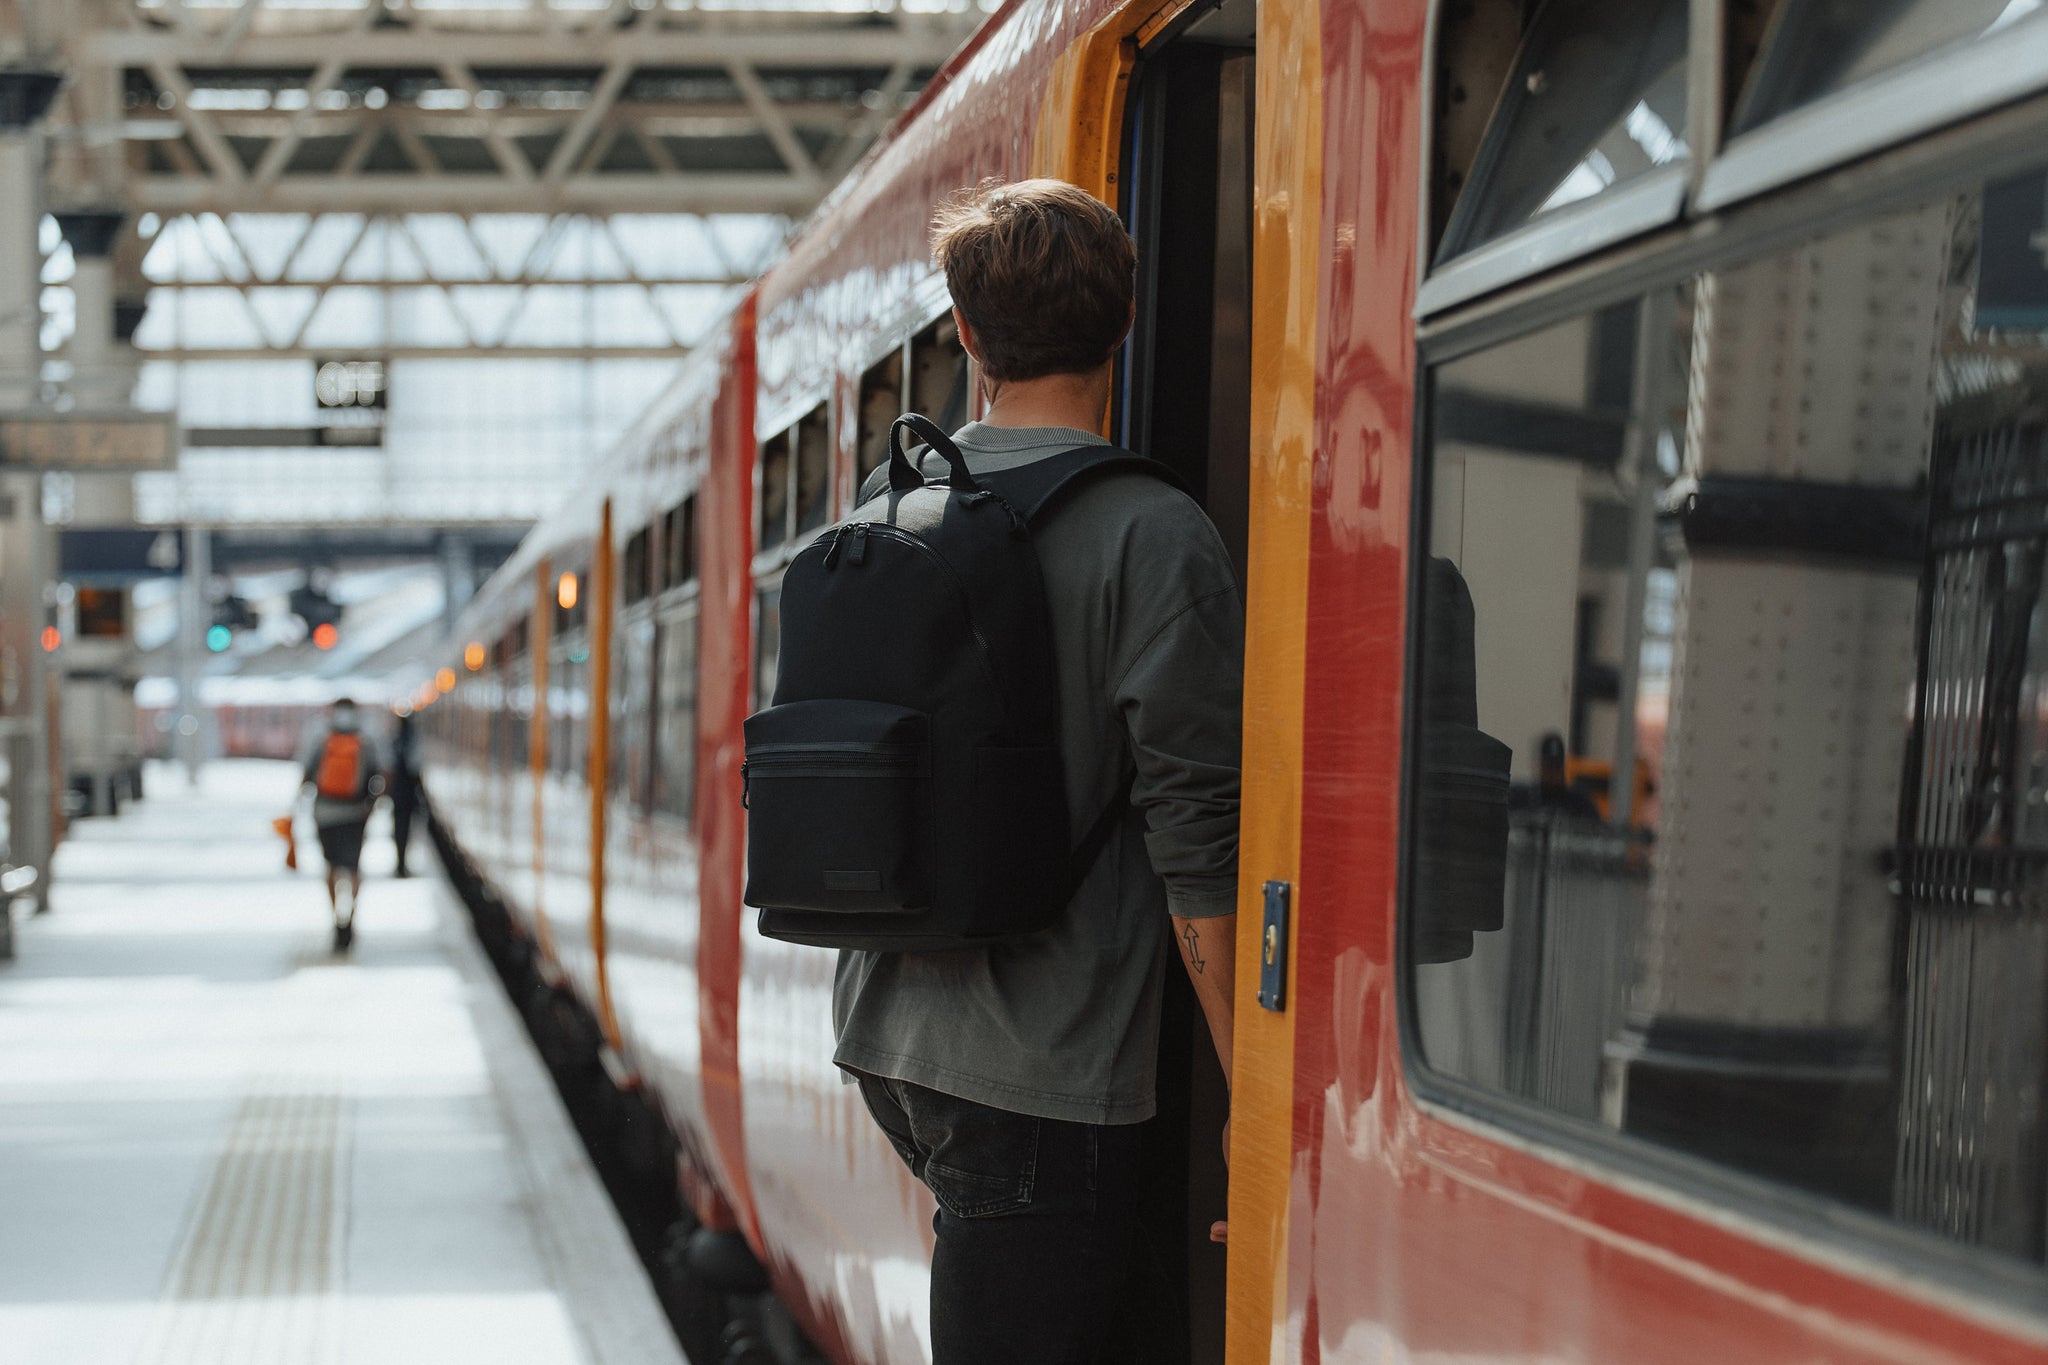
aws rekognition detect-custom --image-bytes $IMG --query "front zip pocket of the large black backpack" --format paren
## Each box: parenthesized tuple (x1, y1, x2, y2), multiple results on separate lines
(741, 700, 932, 913)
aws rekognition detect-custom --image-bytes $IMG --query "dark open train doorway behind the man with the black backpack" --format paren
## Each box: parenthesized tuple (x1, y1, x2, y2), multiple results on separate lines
(1116, 0, 1257, 1365)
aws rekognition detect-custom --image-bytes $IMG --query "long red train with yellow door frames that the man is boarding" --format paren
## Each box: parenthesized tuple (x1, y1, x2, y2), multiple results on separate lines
(415, 0, 2048, 1365)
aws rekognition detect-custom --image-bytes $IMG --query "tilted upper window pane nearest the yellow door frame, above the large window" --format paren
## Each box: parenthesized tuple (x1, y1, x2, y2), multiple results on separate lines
(1436, 0, 1688, 264)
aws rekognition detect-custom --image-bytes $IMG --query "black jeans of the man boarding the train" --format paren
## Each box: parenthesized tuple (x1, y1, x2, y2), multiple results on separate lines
(860, 1076, 1141, 1365)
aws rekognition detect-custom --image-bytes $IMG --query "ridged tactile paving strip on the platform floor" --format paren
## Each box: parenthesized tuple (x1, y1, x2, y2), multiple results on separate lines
(135, 1089, 348, 1365)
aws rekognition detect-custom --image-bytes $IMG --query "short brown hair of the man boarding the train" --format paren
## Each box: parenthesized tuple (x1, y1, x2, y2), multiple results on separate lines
(932, 180, 1139, 383)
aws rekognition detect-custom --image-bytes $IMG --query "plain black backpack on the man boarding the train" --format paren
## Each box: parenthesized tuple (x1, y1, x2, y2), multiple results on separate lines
(741, 413, 1174, 952)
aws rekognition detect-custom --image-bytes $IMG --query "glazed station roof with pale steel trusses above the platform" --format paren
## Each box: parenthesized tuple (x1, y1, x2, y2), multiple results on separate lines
(0, 0, 995, 526)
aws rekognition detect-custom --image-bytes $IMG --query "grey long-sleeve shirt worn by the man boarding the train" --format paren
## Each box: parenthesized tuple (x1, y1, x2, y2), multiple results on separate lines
(834, 424, 1245, 1124)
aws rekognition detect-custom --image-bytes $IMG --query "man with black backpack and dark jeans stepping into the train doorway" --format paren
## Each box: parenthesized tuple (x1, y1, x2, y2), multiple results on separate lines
(748, 180, 1243, 1365)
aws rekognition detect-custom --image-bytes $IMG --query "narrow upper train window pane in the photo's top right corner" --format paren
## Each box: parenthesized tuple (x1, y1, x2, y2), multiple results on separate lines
(1731, 0, 2048, 133)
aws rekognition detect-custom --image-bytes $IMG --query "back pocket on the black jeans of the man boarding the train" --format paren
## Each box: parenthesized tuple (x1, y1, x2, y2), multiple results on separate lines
(860, 1076, 1038, 1218)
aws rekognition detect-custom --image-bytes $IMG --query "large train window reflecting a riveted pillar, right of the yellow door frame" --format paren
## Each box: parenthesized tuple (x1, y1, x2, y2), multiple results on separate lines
(1405, 162, 2048, 1261)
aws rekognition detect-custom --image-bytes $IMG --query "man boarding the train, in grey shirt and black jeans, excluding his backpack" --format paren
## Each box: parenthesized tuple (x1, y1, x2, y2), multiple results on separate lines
(834, 180, 1243, 1365)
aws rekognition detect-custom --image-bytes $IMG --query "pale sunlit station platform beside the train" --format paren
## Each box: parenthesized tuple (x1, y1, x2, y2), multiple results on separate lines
(0, 761, 684, 1365)
